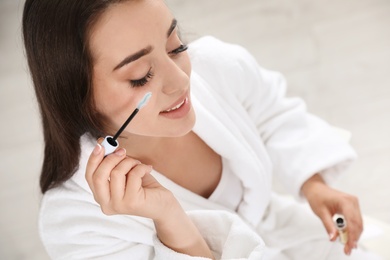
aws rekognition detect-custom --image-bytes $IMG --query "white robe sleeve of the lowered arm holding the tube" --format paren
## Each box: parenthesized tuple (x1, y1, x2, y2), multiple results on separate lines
(192, 37, 356, 198)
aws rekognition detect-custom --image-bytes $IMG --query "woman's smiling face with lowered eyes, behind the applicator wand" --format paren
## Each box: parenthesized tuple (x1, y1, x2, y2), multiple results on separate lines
(89, 0, 195, 137)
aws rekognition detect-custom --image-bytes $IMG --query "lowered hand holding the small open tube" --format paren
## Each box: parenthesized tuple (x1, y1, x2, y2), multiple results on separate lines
(302, 174, 363, 255)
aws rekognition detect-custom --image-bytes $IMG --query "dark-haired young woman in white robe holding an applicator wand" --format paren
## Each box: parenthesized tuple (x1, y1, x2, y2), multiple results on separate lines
(23, 0, 380, 259)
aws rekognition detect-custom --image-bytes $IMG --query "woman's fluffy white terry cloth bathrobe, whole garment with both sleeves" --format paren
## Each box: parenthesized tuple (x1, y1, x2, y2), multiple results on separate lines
(40, 37, 380, 260)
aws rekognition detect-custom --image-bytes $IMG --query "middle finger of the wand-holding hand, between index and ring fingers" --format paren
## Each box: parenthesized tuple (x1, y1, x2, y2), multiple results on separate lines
(92, 148, 126, 206)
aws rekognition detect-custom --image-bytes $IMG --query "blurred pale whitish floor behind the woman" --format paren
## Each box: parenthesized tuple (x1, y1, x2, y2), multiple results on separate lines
(0, 0, 390, 260)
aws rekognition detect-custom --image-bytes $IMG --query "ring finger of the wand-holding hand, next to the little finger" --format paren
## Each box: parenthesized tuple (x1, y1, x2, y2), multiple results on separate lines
(110, 157, 141, 201)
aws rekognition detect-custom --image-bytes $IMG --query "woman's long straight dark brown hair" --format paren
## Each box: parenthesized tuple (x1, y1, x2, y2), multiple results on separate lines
(23, 0, 123, 193)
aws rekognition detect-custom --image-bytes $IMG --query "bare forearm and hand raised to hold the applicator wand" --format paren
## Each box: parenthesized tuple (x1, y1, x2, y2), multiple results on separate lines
(86, 145, 213, 258)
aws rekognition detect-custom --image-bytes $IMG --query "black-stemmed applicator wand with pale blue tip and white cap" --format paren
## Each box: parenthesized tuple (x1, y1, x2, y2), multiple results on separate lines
(102, 92, 152, 156)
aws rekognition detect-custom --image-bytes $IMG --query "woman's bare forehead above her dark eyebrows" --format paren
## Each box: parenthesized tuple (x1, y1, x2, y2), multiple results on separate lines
(89, 0, 173, 64)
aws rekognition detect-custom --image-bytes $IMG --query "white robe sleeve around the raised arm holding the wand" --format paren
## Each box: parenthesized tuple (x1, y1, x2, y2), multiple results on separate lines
(39, 176, 264, 260)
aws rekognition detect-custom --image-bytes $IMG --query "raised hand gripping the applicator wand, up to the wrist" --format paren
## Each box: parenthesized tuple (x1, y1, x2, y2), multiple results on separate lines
(86, 144, 178, 220)
